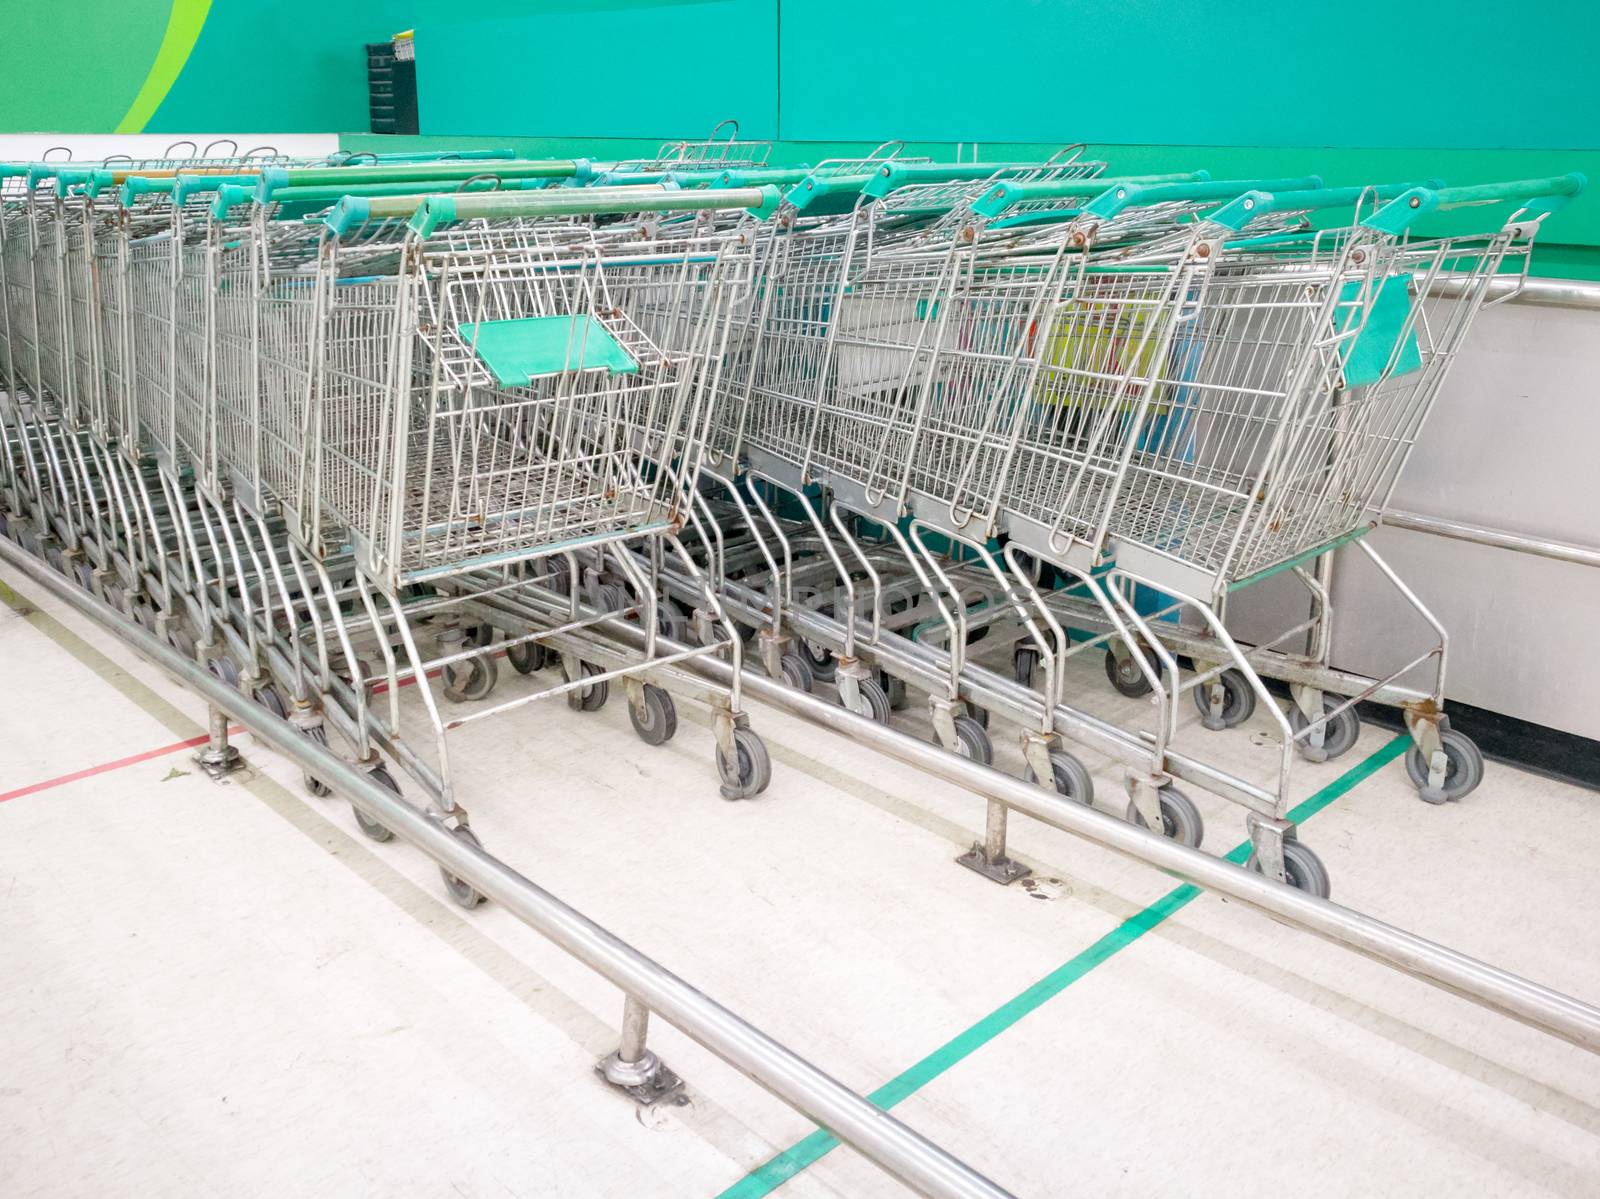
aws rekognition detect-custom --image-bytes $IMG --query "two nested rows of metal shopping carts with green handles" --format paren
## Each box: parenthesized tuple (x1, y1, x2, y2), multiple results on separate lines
(0, 130, 1582, 906)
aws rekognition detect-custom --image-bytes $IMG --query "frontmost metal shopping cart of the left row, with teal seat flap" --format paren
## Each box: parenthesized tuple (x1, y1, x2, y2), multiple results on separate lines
(280, 189, 776, 896)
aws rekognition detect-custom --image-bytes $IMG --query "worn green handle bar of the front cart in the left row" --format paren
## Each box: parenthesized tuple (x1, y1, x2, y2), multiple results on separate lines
(325, 187, 781, 237)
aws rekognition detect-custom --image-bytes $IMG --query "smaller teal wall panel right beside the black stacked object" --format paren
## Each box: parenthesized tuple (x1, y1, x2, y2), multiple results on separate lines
(416, 0, 778, 139)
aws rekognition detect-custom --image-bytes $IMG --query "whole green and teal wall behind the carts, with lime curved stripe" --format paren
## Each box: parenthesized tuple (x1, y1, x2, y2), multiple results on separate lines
(0, 0, 1600, 279)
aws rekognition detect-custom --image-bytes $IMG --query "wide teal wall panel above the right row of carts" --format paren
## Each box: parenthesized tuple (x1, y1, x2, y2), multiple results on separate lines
(779, 0, 1600, 149)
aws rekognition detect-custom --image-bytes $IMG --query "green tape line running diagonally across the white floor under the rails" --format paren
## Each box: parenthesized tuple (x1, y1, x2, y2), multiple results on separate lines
(717, 733, 1411, 1199)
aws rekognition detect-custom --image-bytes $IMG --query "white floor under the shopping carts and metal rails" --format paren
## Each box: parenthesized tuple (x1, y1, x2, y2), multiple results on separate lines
(0, 560, 1600, 1199)
